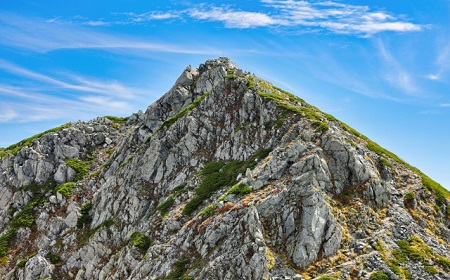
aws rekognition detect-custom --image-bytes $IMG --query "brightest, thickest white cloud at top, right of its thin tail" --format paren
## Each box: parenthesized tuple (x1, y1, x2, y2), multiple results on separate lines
(183, 0, 423, 36)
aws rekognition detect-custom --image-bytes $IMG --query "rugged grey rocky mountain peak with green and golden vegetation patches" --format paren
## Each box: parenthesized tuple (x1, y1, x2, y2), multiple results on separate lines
(0, 58, 450, 280)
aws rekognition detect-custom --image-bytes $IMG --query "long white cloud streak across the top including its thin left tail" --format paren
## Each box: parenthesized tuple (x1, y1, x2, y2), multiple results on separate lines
(37, 0, 426, 36)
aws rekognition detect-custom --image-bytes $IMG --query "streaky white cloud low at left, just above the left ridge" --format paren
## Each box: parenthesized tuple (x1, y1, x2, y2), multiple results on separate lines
(0, 60, 146, 123)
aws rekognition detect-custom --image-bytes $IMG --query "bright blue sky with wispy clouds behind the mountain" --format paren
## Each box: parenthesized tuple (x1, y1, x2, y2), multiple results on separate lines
(0, 0, 450, 188)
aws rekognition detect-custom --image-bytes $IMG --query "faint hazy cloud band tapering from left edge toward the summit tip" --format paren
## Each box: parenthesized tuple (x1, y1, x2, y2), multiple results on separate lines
(0, 11, 219, 55)
